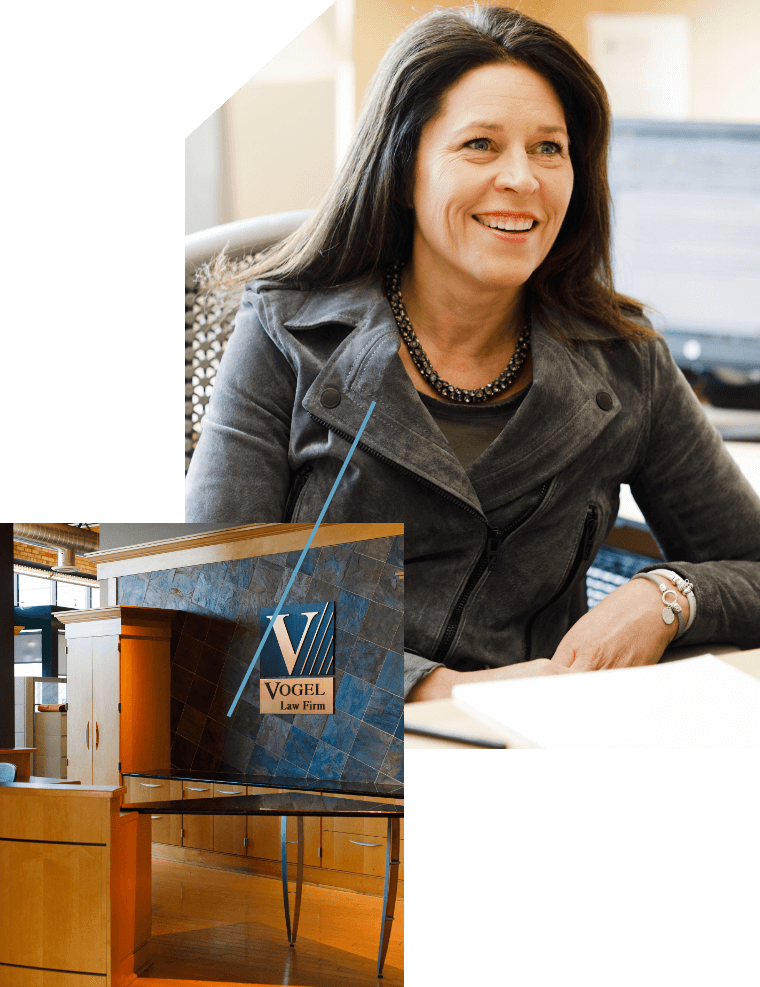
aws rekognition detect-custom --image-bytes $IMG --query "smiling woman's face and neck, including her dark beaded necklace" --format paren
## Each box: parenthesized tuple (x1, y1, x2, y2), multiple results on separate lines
(394, 58, 573, 404)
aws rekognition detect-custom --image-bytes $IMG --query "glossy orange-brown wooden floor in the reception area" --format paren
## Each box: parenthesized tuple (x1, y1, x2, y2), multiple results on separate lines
(133, 857, 404, 987)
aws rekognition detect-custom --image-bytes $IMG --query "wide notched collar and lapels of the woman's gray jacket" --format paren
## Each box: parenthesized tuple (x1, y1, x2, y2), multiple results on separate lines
(264, 279, 621, 513)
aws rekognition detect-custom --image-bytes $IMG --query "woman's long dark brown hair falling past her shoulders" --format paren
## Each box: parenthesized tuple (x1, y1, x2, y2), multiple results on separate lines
(196, 3, 658, 346)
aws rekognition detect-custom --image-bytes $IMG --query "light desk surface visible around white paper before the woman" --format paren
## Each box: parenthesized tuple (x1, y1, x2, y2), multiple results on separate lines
(404, 644, 760, 750)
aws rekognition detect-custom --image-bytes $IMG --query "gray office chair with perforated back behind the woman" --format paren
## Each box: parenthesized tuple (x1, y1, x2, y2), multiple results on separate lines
(185, 209, 311, 473)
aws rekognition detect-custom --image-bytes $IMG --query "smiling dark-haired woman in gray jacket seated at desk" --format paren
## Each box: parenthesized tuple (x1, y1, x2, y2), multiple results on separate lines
(185, 4, 760, 704)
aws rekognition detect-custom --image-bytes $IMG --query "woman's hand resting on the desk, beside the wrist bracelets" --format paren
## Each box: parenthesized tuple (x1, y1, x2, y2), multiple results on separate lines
(552, 579, 689, 672)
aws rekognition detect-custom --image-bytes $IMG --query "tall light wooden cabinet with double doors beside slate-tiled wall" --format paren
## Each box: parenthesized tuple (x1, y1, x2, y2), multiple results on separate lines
(56, 606, 175, 785)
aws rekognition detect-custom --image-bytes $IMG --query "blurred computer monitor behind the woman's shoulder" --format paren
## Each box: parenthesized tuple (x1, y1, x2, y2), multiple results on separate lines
(609, 119, 760, 381)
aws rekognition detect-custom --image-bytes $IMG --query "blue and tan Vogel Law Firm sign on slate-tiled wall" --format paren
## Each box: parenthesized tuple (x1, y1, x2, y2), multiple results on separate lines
(259, 602, 335, 714)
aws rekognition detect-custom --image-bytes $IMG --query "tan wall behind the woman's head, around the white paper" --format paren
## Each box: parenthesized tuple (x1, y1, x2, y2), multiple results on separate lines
(354, 0, 760, 123)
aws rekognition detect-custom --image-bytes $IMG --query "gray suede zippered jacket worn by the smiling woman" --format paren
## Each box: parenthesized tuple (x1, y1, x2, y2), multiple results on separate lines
(185, 279, 760, 695)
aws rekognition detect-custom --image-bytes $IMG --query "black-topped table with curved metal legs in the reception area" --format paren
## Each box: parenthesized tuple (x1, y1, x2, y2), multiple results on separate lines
(122, 792, 404, 977)
